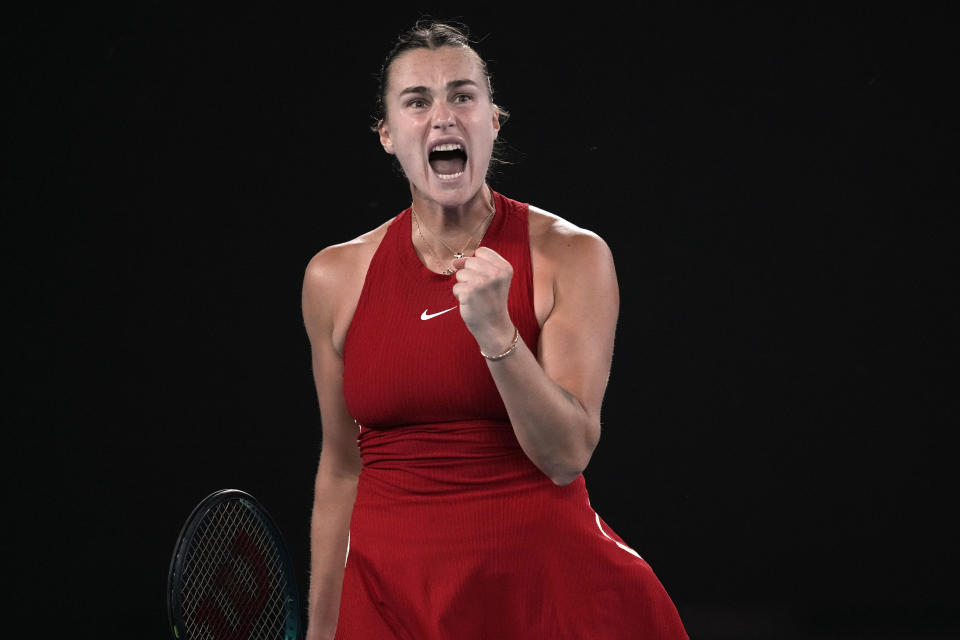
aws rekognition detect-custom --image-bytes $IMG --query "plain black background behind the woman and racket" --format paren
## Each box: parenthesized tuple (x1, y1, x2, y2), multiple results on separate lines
(0, 2, 960, 639)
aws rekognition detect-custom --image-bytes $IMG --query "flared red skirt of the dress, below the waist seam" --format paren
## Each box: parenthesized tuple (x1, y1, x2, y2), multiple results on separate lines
(336, 422, 687, 640)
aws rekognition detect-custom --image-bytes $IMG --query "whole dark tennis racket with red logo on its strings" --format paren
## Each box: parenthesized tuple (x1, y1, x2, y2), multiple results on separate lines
(167, 489, 303, 640)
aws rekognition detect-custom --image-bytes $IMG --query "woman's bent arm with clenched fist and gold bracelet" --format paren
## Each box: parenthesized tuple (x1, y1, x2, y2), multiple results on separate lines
(453, 225, 620, 486)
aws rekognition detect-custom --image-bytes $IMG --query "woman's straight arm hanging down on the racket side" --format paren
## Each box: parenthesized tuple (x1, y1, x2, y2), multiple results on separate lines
(302, 249, 361, 640)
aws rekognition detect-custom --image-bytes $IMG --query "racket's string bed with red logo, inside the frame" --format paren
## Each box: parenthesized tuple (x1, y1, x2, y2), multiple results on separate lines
(181, 500, 297, 640)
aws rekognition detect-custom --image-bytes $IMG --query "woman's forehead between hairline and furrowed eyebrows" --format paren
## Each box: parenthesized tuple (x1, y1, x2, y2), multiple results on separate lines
(387, 47, 486, 93)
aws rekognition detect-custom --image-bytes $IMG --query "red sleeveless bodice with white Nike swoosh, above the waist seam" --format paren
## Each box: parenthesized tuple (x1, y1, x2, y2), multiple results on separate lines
(343, 193, 540, 429)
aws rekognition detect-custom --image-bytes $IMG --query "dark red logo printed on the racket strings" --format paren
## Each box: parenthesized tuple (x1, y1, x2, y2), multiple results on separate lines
(193, 531, 270, 640)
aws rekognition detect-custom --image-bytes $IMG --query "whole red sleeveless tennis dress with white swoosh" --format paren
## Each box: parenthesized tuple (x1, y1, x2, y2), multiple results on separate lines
(336, 194, 687, 640)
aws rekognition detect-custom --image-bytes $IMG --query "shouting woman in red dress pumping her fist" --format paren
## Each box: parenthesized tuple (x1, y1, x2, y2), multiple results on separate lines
(303, 23, 686, 640)
